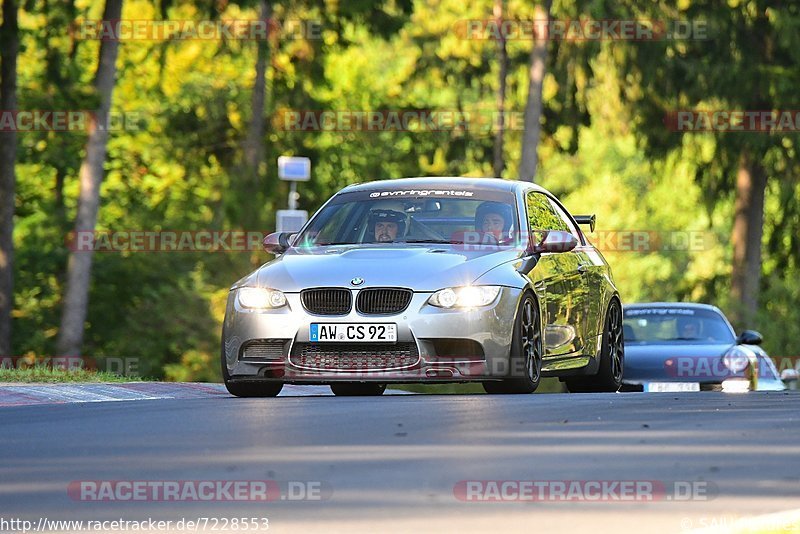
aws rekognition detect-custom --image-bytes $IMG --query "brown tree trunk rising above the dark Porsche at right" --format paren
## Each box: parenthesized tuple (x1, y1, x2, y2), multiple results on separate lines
(731, 152, 767, 328)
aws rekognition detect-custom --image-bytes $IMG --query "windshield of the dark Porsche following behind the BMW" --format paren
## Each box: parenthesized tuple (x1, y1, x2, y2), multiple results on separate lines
(623, 307, 735, 343)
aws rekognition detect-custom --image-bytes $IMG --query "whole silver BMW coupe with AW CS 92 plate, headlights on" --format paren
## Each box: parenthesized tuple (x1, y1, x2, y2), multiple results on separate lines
(221, 178, 624, 397)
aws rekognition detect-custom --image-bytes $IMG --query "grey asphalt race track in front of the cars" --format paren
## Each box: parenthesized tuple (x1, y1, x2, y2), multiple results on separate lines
(0, 392, 800, 533)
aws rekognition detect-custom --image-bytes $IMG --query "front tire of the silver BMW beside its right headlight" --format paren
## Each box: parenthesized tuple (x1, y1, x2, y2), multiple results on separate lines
(483, 293, 543, 394)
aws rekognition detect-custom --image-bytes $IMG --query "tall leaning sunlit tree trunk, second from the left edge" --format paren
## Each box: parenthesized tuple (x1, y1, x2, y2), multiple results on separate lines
(57, 0, 122, 356)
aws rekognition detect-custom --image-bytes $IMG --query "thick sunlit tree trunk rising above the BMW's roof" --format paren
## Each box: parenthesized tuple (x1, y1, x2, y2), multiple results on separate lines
(519, 0, 553, 182)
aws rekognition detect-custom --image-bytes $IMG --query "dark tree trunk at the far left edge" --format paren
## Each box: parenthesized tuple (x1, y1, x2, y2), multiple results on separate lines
(0, 0, 19, 356)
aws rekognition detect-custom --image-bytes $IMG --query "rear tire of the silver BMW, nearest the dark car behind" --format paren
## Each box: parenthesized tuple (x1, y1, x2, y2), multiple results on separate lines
(565, 299, 625, 393)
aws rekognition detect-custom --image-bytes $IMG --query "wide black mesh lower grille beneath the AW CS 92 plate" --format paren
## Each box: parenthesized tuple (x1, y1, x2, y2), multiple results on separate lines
(289, 343, 419, 372)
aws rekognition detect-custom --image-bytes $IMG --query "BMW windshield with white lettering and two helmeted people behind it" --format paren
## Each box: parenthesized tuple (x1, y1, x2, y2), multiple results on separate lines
(295, 189, 519, 247)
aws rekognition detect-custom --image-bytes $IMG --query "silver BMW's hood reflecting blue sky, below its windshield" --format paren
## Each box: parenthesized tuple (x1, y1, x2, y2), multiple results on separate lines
(233, 245, 522, 293)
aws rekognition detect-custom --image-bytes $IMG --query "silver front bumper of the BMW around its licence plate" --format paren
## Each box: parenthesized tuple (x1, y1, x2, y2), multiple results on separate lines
(222, 287, 522, 384)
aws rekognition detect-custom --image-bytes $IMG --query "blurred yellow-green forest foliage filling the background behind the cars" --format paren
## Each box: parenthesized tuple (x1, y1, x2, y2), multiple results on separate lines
(6, 0, 800, 386)
